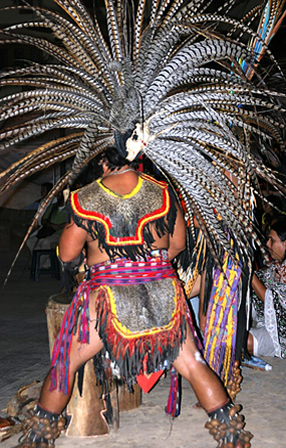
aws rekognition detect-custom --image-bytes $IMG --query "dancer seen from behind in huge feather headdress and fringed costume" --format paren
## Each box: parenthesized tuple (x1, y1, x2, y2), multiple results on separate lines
(0, 0, 285, 447)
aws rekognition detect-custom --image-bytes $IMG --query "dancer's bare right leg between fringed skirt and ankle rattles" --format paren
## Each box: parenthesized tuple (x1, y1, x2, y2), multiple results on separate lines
(173, 327, 229, 412)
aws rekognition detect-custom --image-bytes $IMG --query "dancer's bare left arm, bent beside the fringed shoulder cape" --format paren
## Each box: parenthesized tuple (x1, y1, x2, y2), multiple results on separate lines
(59, 219, 87, 263)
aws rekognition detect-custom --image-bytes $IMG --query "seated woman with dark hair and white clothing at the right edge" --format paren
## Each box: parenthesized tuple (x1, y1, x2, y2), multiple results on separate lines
(247, 220, 286, 357)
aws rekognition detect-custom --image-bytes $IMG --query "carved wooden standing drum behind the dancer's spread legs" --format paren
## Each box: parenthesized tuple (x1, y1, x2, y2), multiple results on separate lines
(46, 293, 142, 437)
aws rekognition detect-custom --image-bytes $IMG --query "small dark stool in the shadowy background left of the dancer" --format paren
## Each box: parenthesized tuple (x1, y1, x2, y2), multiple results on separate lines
(30, 249, 61, 282)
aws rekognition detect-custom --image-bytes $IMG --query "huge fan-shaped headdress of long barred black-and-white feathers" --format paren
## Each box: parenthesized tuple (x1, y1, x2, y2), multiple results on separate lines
(0, 0, 285, 278)
